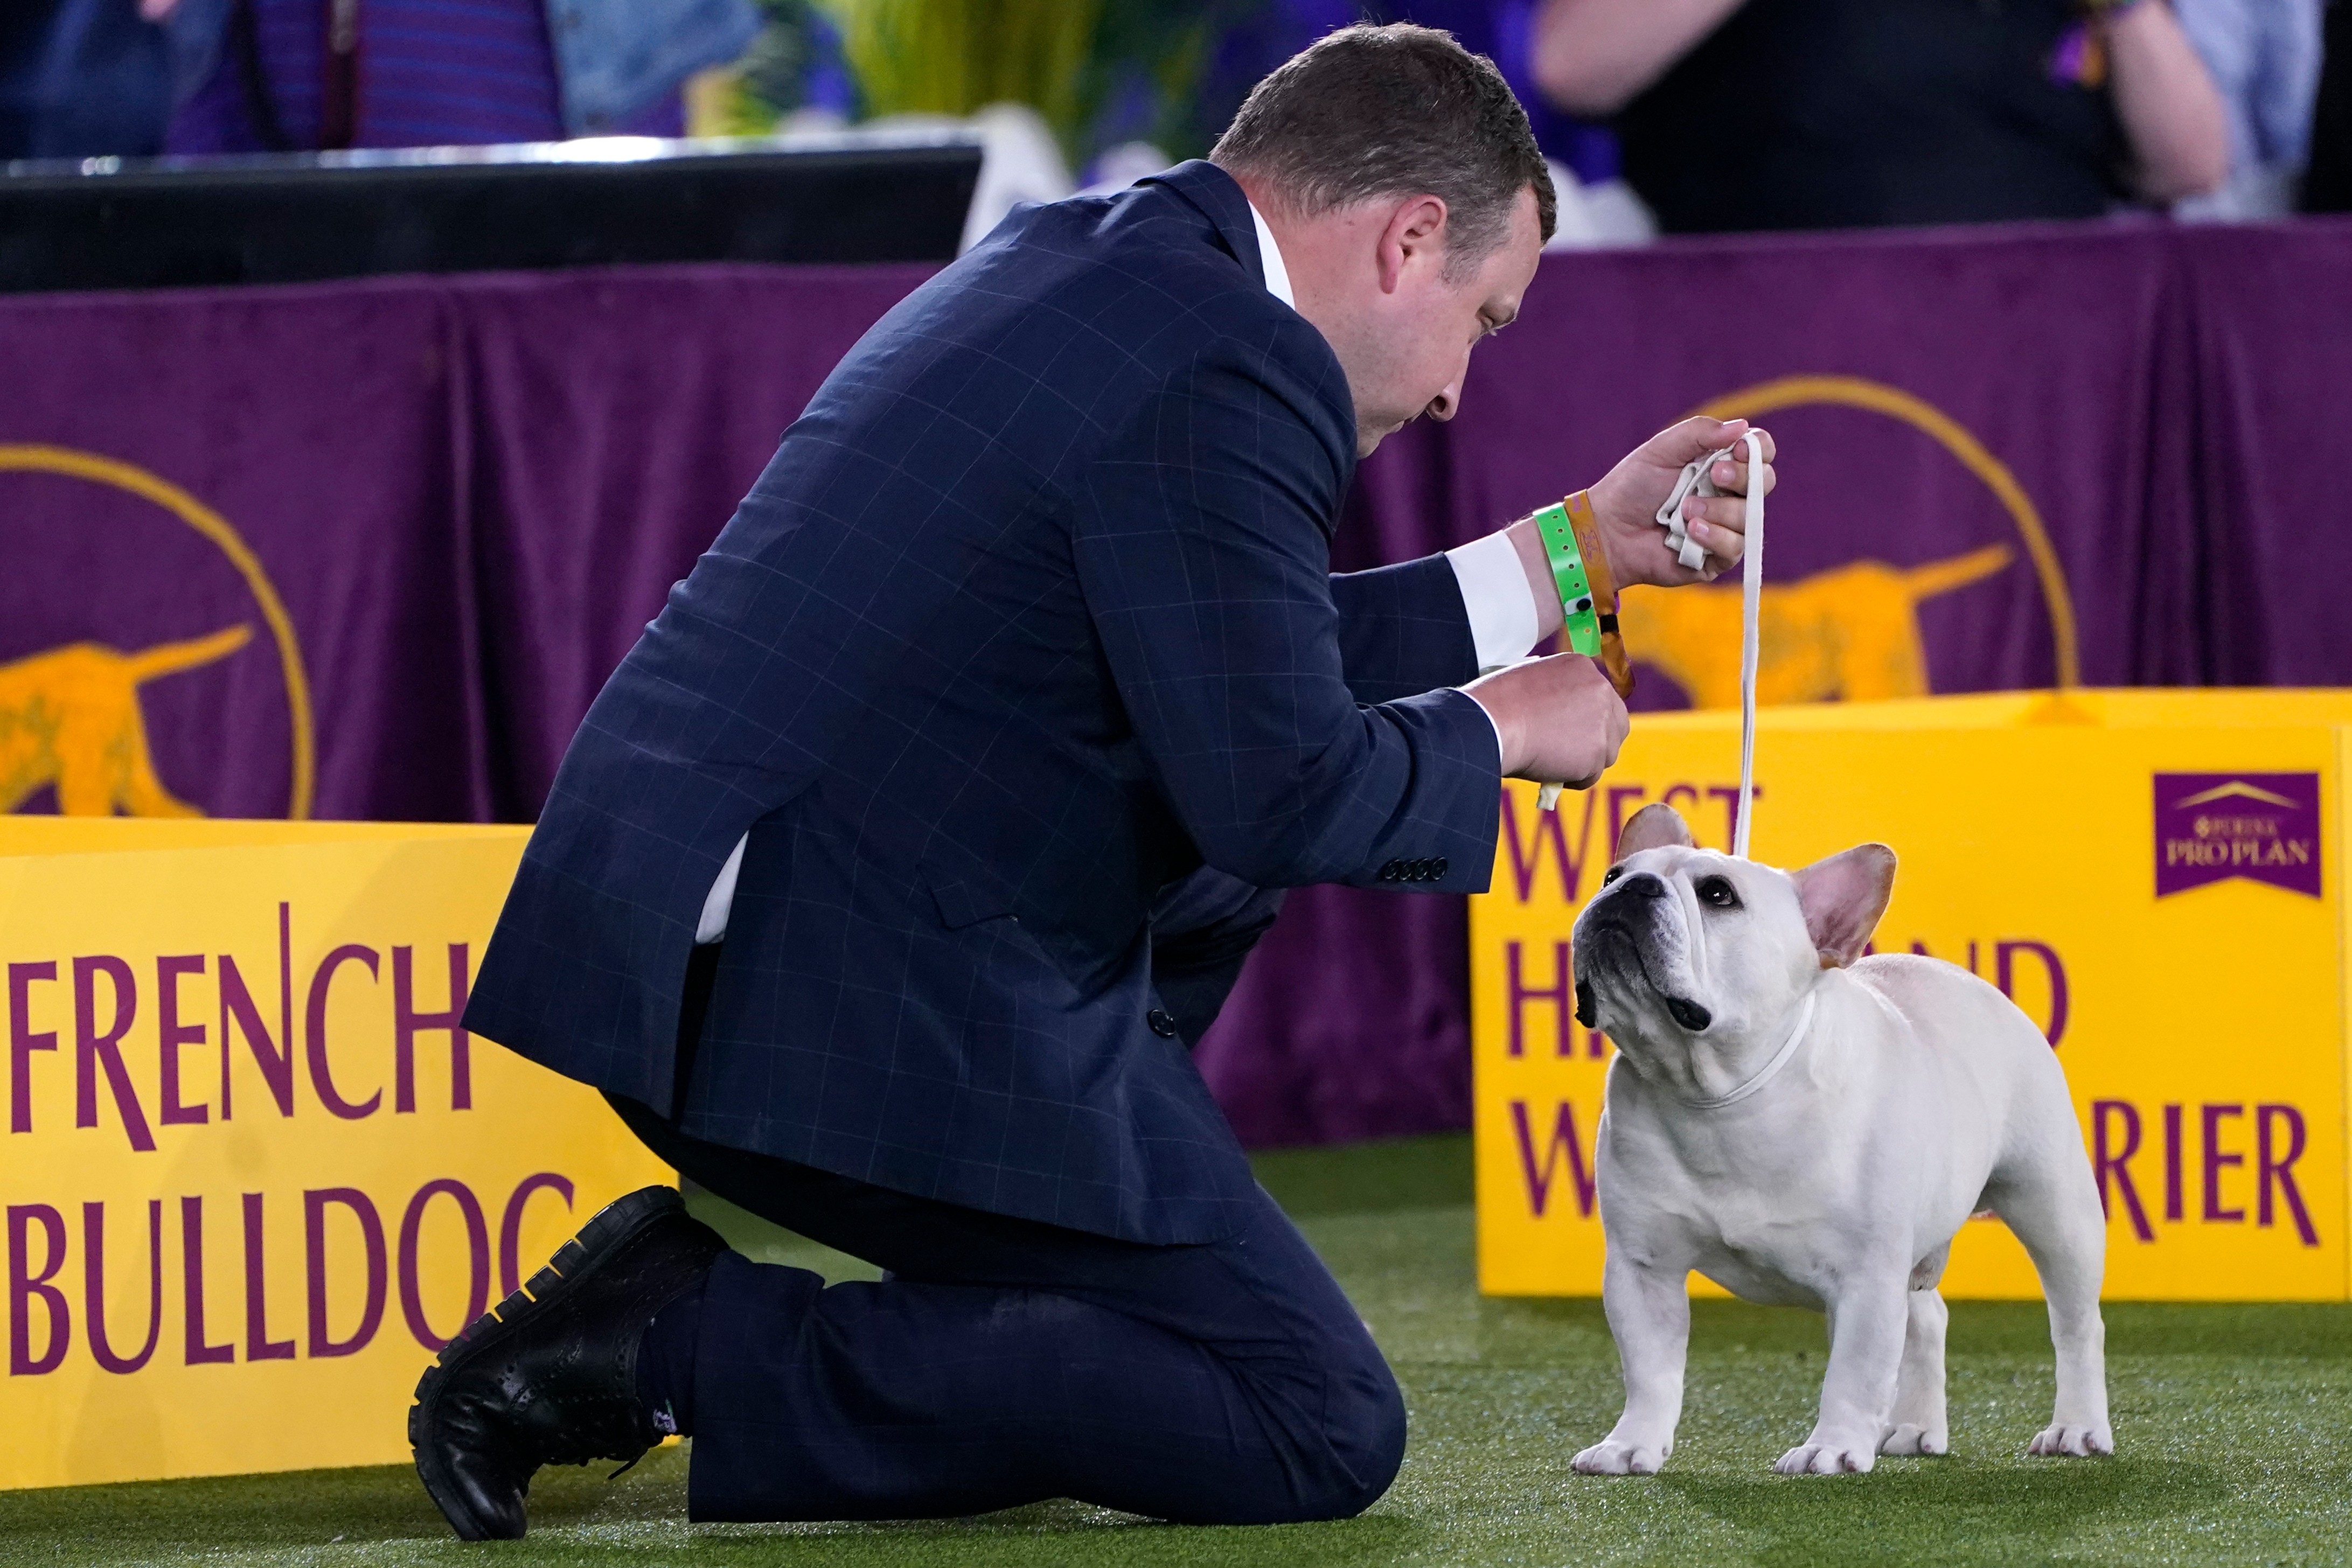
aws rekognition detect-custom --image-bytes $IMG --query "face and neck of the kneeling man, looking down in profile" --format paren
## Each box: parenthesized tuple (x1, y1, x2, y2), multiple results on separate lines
(1317, 191, 1543, 456)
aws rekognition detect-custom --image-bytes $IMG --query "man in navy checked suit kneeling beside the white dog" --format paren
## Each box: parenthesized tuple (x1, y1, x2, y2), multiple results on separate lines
(409, 26, 1769, 1537)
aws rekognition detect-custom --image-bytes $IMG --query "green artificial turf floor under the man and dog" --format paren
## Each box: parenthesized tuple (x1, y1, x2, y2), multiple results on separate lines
(0, 1138, 2352, 1568)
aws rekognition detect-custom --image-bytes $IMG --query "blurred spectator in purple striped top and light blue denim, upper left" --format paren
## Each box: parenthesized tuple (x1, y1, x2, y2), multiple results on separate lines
(141, 0, 760, 153)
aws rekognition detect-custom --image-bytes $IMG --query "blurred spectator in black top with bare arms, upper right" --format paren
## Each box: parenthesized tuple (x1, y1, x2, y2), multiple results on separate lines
(1536, 0, 2230, 233)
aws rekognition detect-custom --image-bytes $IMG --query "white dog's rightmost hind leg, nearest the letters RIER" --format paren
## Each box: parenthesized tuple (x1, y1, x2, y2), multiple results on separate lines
(1987, 1166, 2114, 1458)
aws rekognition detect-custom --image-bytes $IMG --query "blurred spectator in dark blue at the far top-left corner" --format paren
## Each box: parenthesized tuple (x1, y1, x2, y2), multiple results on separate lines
(0, 0, 172, 160)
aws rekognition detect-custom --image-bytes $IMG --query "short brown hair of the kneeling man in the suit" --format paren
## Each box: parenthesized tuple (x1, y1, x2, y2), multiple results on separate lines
(1209, 21, 1557, 277)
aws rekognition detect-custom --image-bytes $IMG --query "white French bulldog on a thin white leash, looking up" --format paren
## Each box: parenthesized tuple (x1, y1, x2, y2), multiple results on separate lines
(1576, 806, 2114, 1476)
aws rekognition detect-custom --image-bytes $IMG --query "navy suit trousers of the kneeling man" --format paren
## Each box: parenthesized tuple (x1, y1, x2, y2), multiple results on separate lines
(611, 872, 1404, 1523)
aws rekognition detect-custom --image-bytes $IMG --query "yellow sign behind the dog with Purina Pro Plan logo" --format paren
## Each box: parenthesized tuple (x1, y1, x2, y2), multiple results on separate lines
(1470, 691, 2352, 1300)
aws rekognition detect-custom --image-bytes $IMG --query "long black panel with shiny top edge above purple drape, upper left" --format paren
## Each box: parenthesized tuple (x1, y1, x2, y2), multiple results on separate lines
(0, 131, 981, 291)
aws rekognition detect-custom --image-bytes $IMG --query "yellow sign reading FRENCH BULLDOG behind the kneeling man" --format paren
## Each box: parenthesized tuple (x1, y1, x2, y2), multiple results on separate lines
(0, 816, 670, 1488)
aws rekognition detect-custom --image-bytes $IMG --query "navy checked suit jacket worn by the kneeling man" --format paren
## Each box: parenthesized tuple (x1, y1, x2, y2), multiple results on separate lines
(465, 162, 1498, 1244)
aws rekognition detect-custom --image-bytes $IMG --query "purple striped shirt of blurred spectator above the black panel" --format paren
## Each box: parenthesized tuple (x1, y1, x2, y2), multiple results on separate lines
(165, 0, 685, 155)
